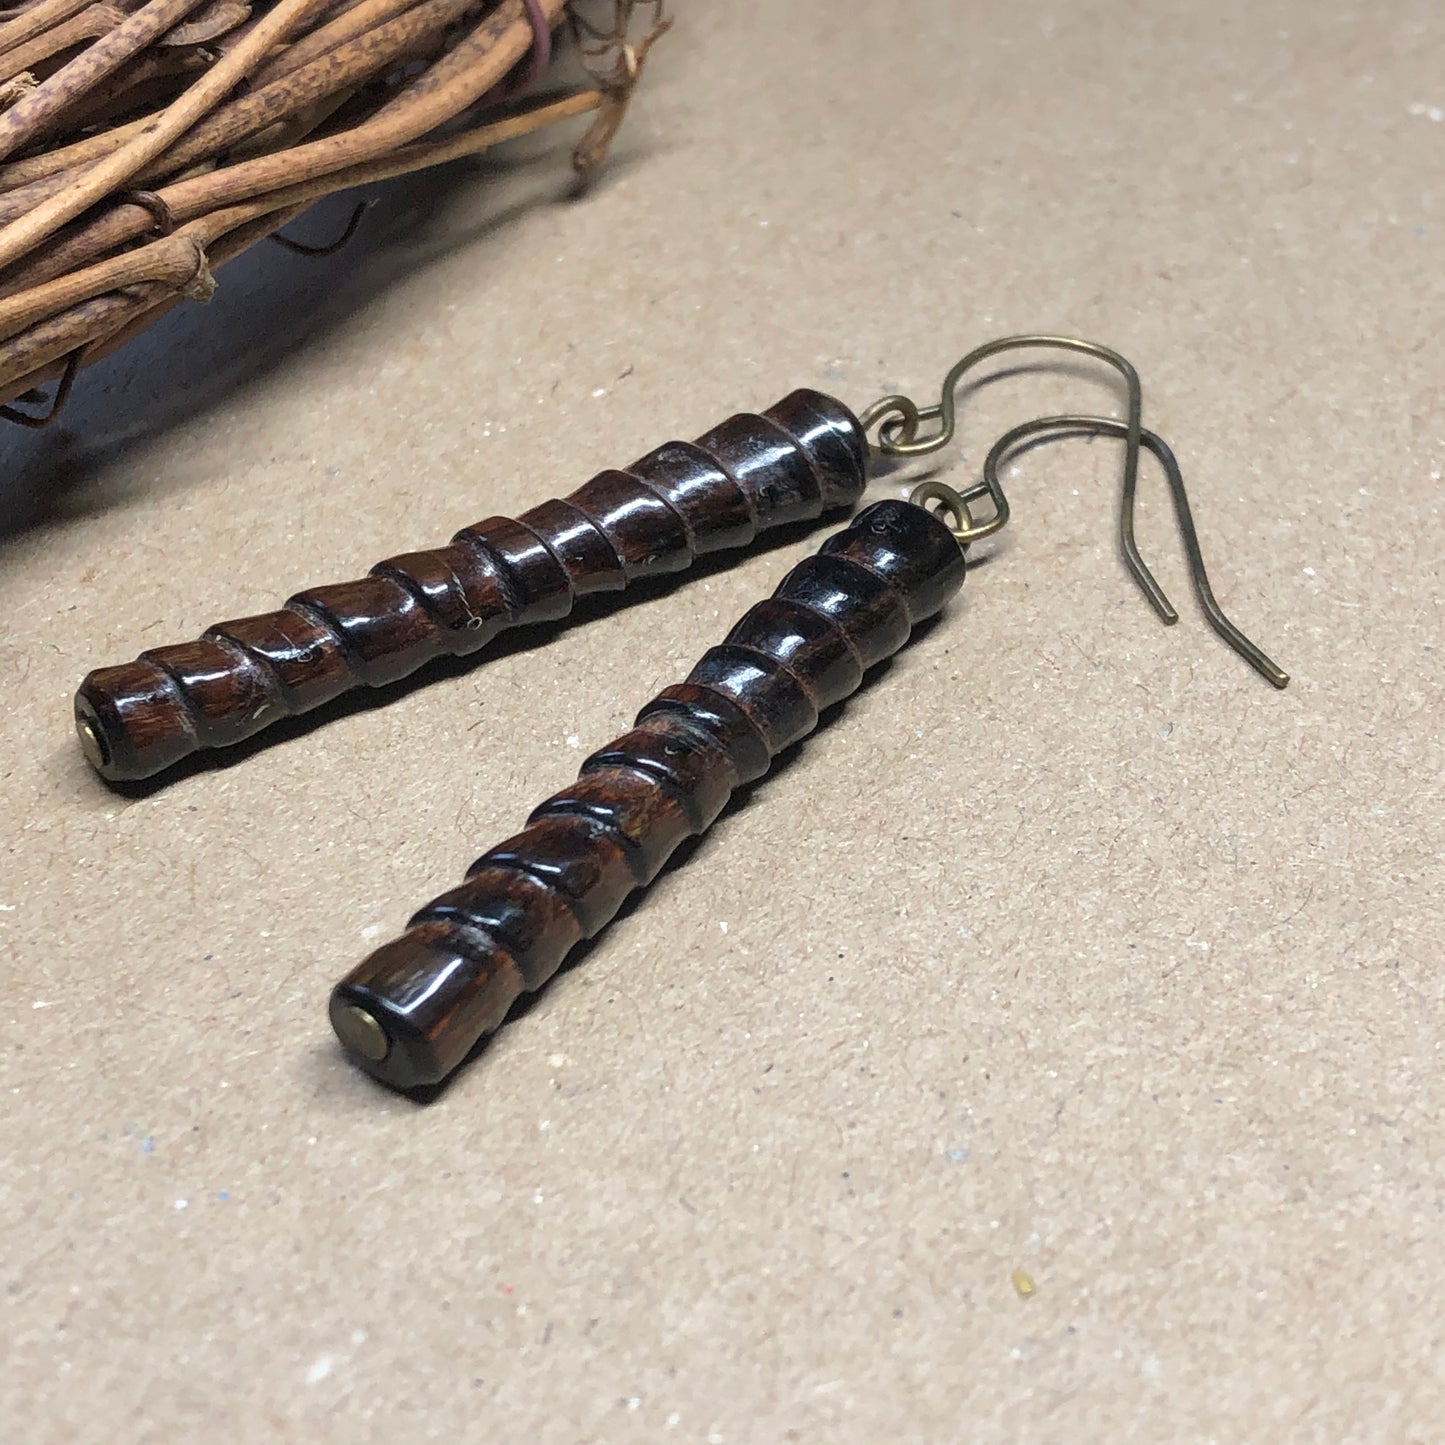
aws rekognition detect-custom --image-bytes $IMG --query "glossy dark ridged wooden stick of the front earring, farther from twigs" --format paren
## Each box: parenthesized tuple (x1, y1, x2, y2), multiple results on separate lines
(331, 501, 964, 1088)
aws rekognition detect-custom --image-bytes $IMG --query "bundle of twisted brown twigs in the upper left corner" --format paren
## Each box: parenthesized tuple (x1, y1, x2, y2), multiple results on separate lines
(0, 0, 665, 420)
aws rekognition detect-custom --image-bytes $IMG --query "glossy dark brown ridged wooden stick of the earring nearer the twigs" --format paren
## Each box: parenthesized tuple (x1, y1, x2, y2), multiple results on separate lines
(75, 390, 867, 782)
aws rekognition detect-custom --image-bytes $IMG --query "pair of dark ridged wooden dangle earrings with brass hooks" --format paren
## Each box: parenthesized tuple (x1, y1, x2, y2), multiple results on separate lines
(75, 335, 1289, 1090)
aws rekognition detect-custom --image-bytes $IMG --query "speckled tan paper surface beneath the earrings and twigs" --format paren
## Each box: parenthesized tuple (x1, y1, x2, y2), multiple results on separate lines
(0, 0, 1445, 1445)
